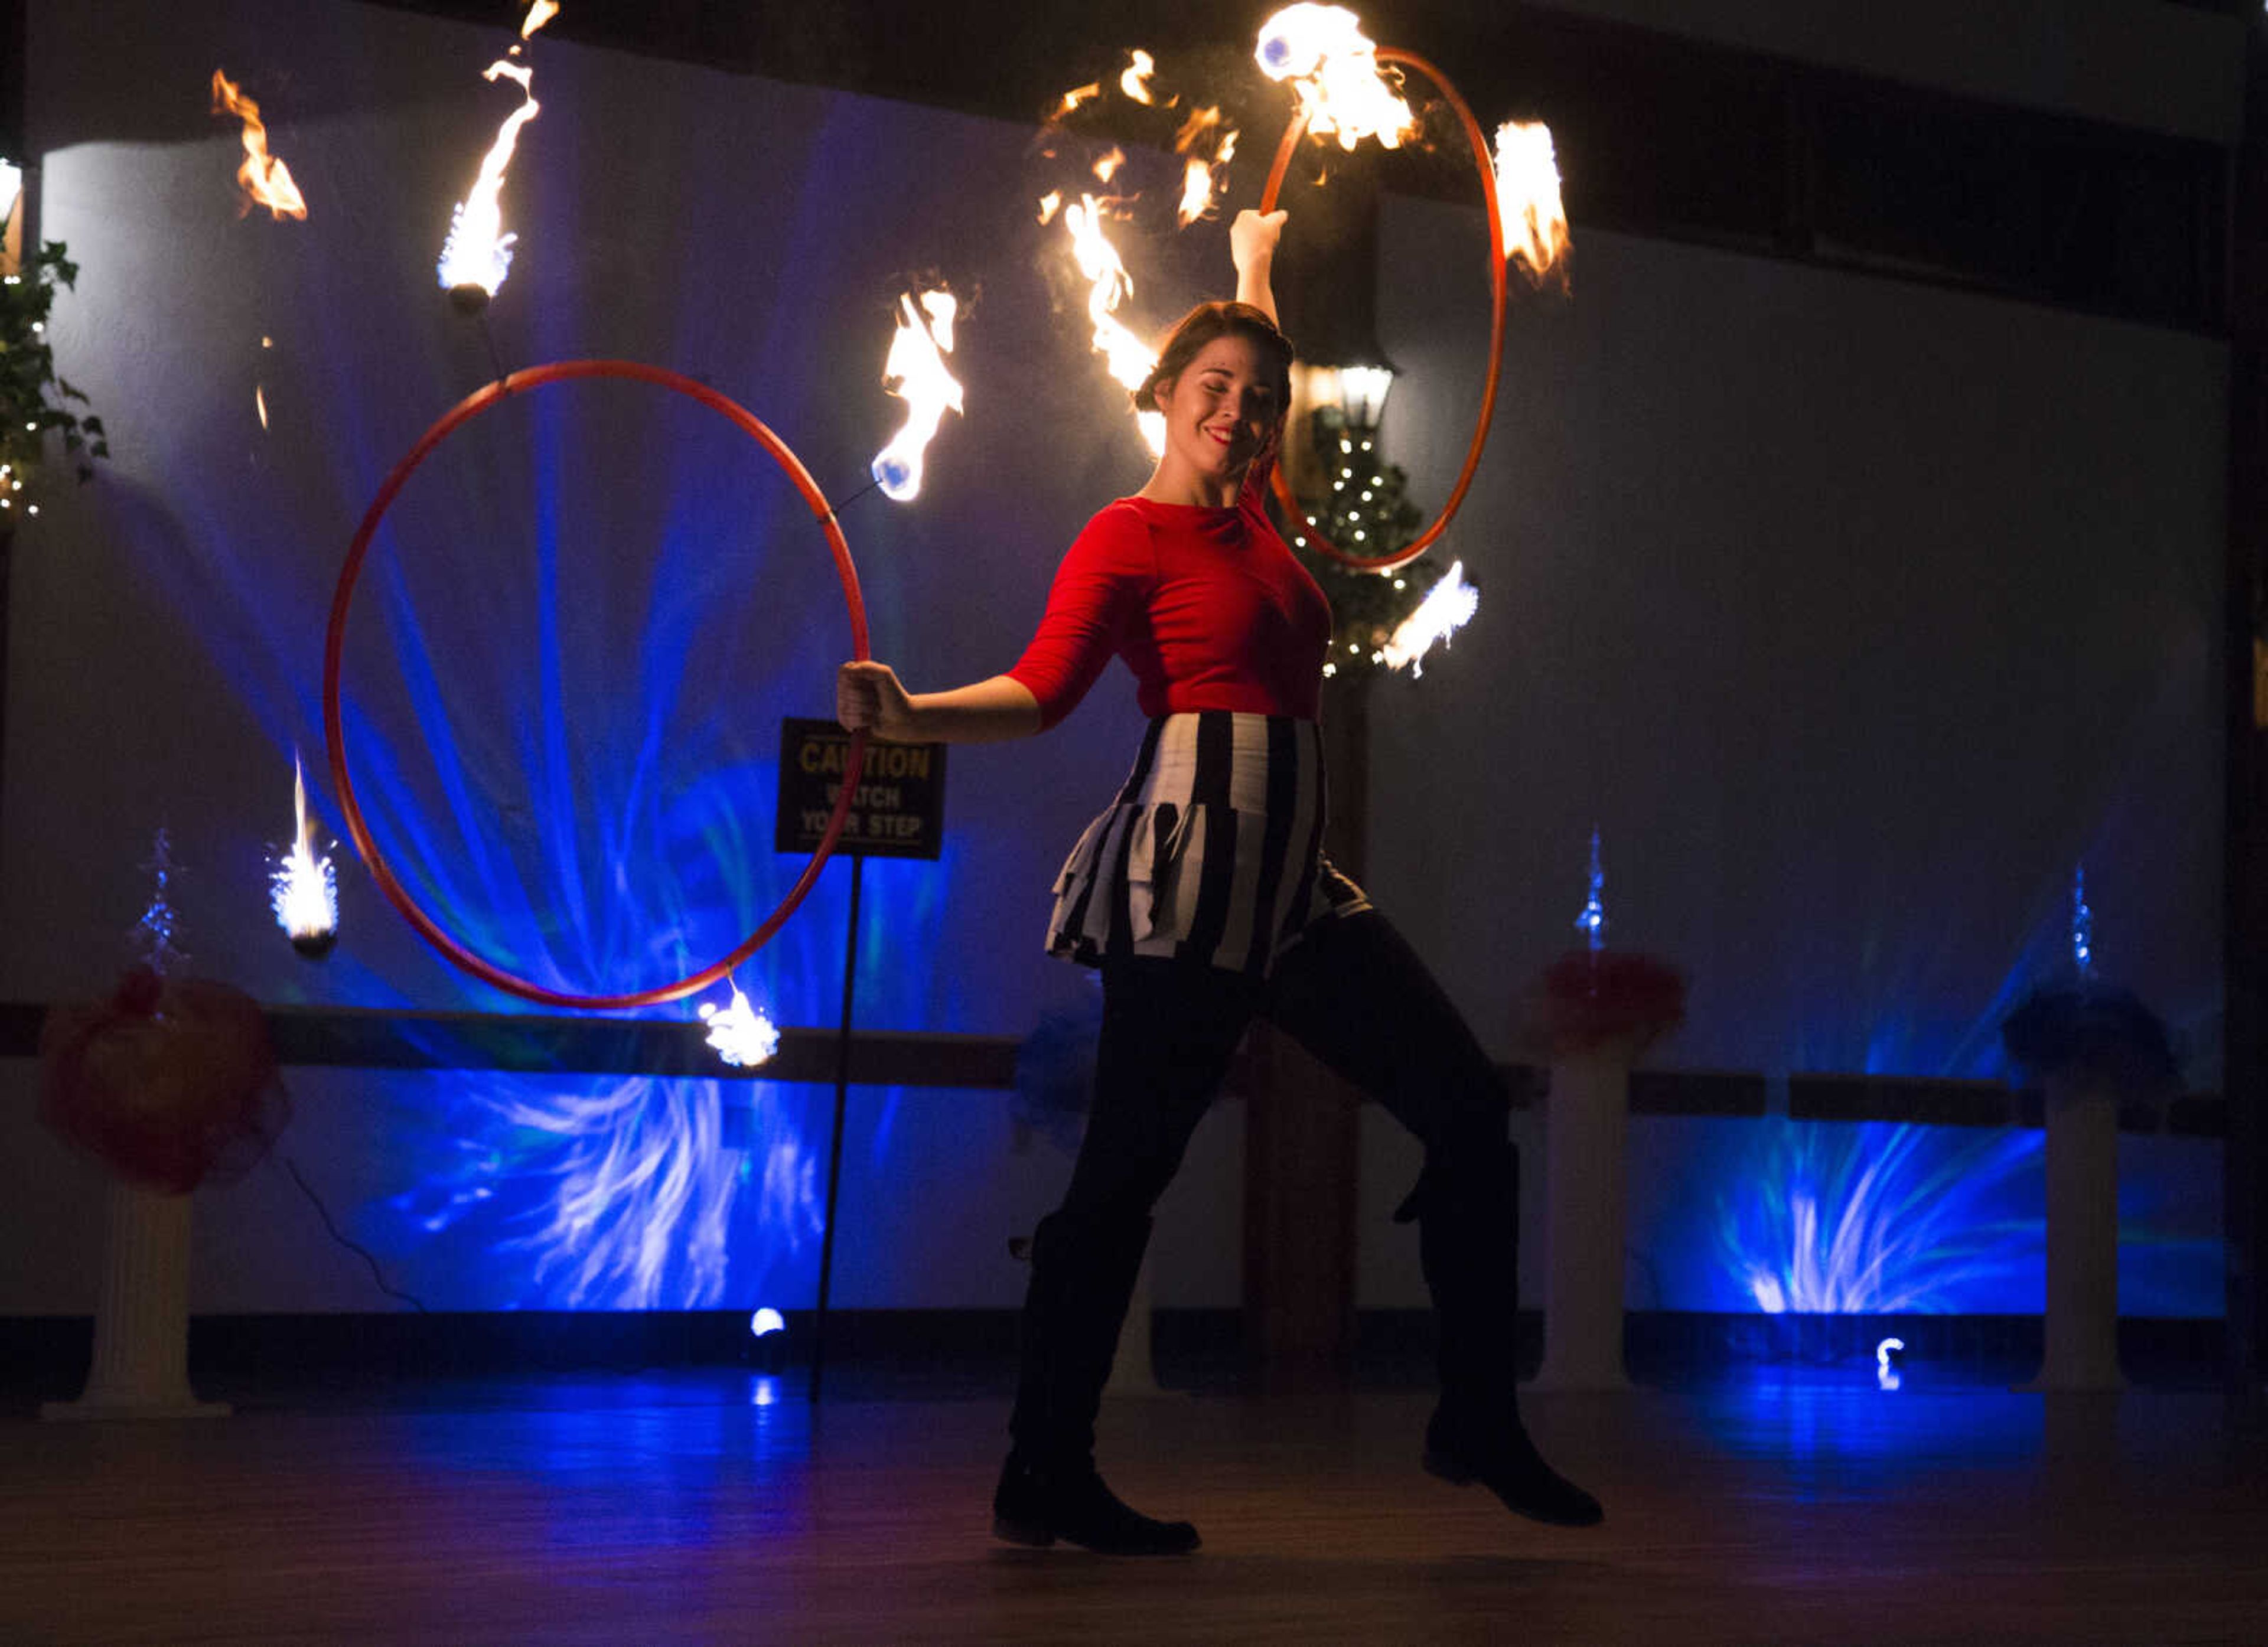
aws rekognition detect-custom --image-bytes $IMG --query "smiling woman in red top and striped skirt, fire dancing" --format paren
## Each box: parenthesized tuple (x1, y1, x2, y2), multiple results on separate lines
(835, 211, 1601, 1554)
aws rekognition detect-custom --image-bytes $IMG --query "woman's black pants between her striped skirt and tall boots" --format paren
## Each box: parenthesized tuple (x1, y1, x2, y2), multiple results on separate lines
(1064, 909, 1510, 1223)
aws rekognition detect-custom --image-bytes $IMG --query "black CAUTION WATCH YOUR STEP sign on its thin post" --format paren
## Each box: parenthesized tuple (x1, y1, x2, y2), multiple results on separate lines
(771, 719, 946, 1402)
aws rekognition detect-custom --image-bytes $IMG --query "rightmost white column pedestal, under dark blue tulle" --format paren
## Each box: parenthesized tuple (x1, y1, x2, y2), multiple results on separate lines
(2019, 1080, 2125, 1391)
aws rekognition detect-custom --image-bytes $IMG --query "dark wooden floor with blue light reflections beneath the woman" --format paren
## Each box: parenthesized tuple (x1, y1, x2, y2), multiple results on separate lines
(0, 1372, 2268, 1647)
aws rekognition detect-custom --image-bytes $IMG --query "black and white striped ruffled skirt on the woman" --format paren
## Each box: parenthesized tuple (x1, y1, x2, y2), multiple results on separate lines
(1048, 710, 1370, 978)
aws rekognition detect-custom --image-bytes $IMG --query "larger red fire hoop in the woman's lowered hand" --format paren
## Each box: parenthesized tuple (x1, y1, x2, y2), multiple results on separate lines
(322, 361, 869, 1012)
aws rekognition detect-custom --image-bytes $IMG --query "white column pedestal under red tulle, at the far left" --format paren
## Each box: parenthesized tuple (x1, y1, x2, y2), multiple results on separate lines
(38, 1182, 229, 1420)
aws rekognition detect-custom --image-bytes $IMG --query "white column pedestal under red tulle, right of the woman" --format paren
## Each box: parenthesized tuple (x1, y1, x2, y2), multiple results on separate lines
(1531, 1048, 1631, 1391)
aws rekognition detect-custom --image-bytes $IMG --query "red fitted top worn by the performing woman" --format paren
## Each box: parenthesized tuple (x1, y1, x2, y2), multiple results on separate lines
(1007, 463, 1331, 728)
